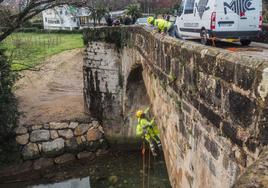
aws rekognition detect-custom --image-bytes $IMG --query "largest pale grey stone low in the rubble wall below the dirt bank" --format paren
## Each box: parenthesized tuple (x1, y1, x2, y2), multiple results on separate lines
(42, 138, 64, 156)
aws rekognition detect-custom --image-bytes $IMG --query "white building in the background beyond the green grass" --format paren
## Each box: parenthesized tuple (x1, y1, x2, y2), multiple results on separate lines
(42, 5, 89, 30)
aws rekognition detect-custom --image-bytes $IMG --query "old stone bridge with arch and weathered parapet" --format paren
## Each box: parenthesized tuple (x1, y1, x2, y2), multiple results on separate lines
(84, 27, 268, 188)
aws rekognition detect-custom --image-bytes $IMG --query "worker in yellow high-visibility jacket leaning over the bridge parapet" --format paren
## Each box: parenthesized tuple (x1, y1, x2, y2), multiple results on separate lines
(147, 16, 176, 37)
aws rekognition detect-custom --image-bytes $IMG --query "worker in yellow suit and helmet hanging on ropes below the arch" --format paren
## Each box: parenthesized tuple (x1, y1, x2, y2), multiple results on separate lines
(136, 109, 162, 156)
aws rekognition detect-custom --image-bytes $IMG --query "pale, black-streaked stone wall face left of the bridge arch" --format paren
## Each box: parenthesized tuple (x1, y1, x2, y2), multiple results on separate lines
(83, 43, 125, 140)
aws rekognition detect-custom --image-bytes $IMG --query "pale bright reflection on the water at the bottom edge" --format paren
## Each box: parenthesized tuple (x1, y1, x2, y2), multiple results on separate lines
(28, 177, 90, 188)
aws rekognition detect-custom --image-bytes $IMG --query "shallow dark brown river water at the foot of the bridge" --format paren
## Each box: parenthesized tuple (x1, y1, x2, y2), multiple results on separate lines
(0, 150, 171, 188)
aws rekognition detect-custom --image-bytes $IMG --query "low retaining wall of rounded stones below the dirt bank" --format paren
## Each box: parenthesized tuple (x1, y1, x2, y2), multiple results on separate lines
(15, 121, 107, 160)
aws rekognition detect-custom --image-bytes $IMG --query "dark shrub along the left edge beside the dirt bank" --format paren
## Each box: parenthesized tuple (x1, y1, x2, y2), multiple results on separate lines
(0, 50, 19, 165)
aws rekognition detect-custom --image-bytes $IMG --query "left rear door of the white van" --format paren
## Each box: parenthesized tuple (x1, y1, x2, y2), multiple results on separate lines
(215, 0, 239, 32)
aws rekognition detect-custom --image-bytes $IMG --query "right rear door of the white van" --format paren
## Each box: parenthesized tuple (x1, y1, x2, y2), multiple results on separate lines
(238, 0, 262, 31)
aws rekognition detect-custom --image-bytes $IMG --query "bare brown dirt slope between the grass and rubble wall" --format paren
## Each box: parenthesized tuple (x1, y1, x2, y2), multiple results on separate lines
(15, 49, 87, 124)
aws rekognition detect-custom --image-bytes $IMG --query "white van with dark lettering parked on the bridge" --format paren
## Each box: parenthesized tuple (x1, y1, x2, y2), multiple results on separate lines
(175, 0, 262, 45)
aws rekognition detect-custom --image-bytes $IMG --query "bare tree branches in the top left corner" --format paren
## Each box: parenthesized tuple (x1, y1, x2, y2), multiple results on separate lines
(0, 0, 88, 42)
